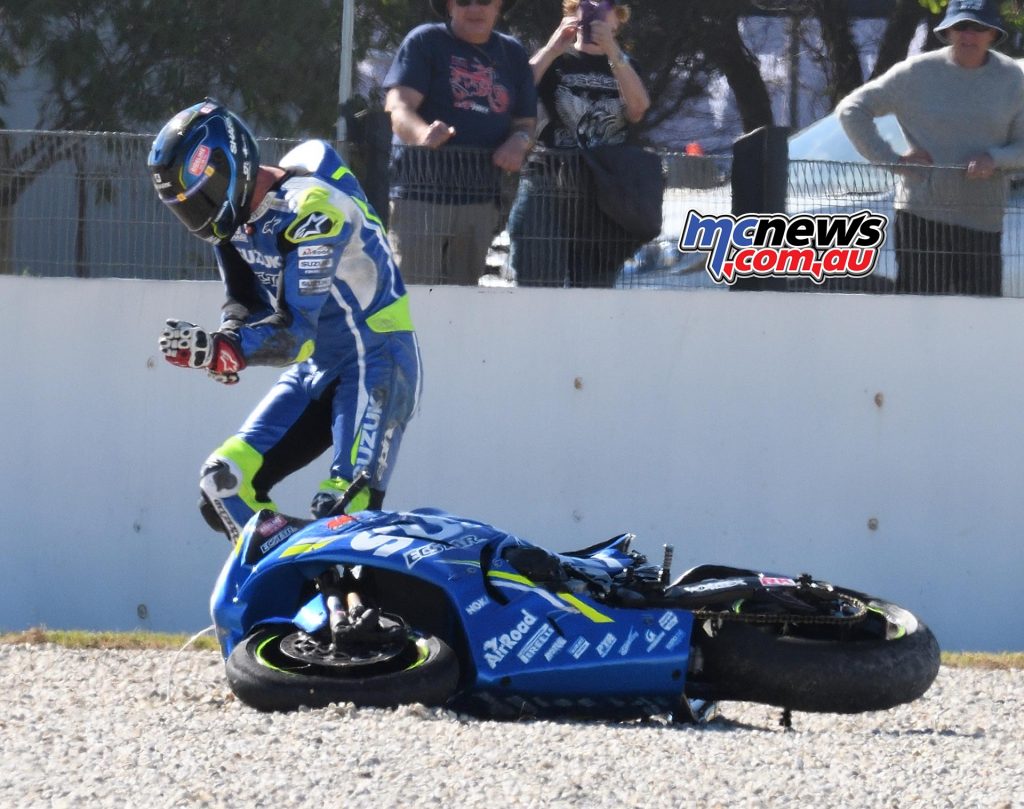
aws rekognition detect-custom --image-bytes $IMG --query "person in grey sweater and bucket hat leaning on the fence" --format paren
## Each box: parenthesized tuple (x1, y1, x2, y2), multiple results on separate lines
(837, 0, 1024, 296)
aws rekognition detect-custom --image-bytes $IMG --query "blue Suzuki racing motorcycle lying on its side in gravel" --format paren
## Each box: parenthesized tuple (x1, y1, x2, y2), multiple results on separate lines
(211, 487, 939, 721)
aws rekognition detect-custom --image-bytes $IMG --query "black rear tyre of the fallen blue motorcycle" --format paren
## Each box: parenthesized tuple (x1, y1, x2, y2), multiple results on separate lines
(692, 590, 939, 714)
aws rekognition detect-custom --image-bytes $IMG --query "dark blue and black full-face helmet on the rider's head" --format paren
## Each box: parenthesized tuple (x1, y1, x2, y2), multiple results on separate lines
(146, 98, 259, 244)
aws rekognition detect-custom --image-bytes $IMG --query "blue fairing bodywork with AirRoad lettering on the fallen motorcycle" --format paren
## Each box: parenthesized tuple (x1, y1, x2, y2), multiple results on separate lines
(211, 509, 693, 710)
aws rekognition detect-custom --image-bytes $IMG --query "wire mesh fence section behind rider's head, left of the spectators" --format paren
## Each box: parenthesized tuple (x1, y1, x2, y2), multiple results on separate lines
(0, 131, 311, 280)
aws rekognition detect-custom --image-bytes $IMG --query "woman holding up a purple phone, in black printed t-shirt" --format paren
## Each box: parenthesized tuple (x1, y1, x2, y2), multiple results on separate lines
(509, 0, 650, 287)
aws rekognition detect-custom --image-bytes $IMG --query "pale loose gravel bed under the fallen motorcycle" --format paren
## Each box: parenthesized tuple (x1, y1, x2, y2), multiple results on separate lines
(0, 645, 1024, 809)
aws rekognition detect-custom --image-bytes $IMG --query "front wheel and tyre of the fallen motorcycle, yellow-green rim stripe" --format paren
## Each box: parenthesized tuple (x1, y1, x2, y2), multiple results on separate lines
(225, 626, 459, 711)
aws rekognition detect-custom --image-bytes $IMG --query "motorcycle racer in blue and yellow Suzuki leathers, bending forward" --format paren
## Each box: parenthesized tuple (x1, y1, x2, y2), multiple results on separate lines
(147, 98, 421, 541)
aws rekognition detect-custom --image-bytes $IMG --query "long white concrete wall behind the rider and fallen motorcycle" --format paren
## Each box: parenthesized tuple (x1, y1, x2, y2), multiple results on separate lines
(0, 278, 1024, 650)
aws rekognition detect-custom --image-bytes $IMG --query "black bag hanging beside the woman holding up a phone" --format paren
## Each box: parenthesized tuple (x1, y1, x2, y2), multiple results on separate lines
(581, 144, 665, 242)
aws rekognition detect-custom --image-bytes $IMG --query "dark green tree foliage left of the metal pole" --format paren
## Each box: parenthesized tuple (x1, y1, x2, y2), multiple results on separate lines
(5, 0, 364, 137)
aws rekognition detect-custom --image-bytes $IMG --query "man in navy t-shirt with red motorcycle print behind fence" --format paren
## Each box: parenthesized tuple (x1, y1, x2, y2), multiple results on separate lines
(384, 0, 537, 284)
